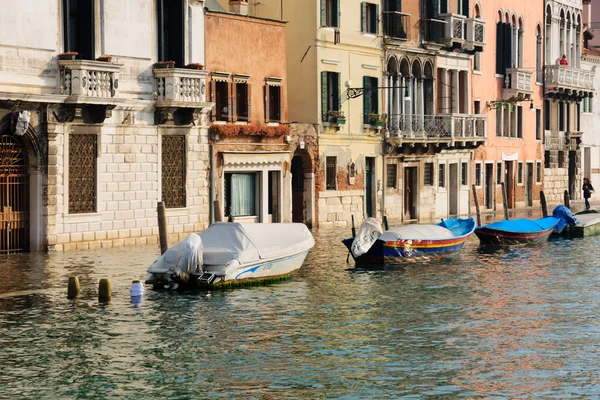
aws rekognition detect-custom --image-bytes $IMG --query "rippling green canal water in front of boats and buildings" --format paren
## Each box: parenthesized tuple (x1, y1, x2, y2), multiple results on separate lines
(0, 230, 600, 399)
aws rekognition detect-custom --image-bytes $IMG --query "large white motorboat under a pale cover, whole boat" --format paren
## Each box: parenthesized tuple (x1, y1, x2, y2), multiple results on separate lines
(146, 222, 315, 288)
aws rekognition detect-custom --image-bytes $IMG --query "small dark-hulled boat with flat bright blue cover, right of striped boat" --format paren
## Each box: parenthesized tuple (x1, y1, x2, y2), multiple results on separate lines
(475, 217, 560, 245)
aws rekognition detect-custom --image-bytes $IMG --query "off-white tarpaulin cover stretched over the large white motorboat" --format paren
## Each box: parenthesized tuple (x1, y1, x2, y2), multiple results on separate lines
(200, 222, 315, 265)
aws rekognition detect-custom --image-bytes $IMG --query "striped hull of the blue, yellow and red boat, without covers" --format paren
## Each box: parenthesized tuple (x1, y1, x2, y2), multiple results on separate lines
(343, 234, 470, 265)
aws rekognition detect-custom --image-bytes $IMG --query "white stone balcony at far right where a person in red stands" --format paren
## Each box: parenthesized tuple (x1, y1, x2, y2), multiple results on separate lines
(544, 65, 596, 100)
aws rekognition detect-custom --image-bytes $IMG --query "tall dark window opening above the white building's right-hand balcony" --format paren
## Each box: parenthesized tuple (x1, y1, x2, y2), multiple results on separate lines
(156, 0, 185, 68)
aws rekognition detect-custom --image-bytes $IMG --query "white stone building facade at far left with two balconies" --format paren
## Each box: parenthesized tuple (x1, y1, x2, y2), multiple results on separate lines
(0, 0, 212, 252)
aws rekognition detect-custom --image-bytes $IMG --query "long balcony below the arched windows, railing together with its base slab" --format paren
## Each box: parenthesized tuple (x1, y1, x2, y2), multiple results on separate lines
(387, 114, 487, 148)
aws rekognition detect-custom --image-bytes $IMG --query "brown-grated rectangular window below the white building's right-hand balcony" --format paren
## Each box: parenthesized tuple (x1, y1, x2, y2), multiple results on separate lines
(161, 135, 186, 208)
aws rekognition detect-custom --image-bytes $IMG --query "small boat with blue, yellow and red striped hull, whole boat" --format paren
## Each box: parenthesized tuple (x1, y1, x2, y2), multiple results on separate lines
(342, 218, 475, 264)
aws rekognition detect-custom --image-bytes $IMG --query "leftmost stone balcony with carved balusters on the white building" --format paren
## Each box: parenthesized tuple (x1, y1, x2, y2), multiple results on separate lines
(58, 60, 122, 106)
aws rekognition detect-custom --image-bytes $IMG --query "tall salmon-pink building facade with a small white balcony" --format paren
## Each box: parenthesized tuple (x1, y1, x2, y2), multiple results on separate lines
(471, 0, 544, 210)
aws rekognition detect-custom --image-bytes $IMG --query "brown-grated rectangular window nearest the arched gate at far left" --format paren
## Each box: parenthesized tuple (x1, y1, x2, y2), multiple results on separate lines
(69, 135, 98, 214)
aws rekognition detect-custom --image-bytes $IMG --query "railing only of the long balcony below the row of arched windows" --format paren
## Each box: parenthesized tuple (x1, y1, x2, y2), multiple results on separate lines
(388, 114, 487, 140)
